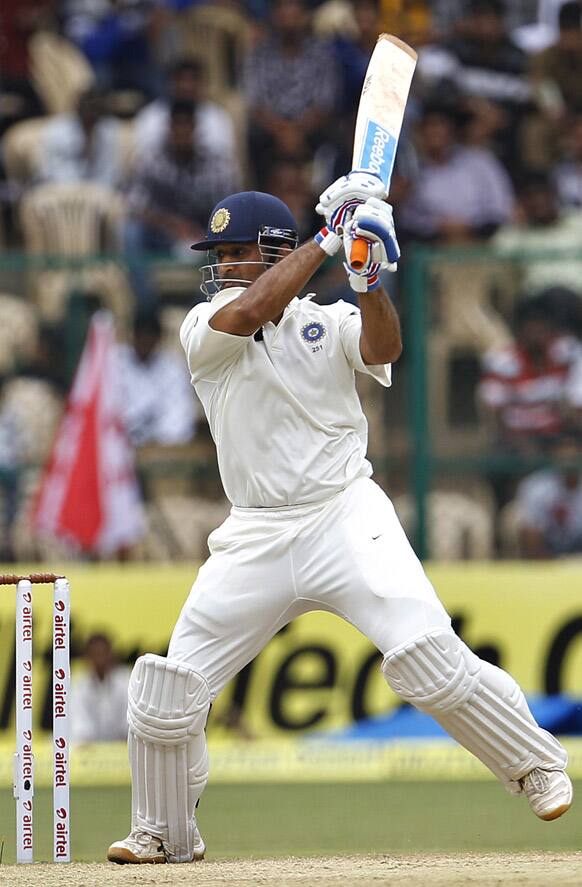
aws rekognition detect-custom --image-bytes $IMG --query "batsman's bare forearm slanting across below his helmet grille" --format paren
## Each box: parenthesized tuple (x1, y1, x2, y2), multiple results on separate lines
(210, 241, 327, 336)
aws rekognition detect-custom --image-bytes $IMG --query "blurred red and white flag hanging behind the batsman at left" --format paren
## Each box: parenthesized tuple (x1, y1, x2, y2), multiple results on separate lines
(33, 311, 144, 555)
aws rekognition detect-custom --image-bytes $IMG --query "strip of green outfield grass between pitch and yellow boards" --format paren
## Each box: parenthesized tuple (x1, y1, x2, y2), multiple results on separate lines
(0, 782, 582, 863)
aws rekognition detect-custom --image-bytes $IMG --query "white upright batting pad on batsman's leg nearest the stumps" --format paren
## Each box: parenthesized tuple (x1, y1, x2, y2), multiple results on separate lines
(127, 653, 210, 862)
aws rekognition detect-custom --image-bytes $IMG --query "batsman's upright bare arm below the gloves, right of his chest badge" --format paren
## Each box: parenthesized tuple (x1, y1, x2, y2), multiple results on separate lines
(359, 287, 402, 366)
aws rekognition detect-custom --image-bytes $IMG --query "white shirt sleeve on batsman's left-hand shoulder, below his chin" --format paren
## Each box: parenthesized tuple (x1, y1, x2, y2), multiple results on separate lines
(180, 287, 253, 385)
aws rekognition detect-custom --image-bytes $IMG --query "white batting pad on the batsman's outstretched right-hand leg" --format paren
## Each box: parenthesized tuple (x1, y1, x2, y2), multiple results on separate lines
(382, 629, 568, 794)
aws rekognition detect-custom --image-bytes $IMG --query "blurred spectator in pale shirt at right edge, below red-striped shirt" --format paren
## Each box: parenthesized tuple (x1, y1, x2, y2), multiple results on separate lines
(516, 432, 582, 558)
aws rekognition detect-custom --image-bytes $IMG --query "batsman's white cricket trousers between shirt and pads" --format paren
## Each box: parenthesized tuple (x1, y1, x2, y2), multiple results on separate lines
(168, 478, 450, 699)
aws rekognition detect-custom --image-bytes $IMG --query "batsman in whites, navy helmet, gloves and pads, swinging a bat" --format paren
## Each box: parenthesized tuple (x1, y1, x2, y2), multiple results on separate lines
(107, 177, 572, 863)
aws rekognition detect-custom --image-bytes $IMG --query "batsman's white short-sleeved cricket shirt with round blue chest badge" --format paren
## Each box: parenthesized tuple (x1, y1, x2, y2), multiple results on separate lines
(180, 287, 391, 508)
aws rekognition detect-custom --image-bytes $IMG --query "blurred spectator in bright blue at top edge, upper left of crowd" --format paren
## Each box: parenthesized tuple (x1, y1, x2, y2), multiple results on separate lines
(61, 0, 164, 98)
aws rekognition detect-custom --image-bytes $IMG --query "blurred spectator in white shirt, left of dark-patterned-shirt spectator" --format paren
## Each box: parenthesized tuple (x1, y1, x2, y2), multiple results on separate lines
(39, 89, 123, 188)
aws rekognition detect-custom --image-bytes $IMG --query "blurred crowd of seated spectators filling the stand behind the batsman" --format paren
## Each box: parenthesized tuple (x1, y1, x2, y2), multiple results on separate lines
(0, 0, 582, 558)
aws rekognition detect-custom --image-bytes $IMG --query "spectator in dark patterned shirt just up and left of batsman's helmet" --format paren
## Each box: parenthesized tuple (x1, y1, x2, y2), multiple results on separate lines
(125, 101, 231, 308)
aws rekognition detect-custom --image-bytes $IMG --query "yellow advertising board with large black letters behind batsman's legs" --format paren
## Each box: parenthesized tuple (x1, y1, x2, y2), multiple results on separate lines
(0, 562, 582, 738)
